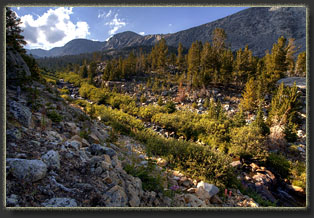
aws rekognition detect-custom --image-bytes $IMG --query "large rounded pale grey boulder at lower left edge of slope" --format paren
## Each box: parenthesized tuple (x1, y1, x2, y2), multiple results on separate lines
(6, 158, 47, 182)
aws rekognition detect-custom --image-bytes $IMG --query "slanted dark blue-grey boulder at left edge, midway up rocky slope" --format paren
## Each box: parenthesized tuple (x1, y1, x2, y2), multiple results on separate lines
(9, 101, 32, 128)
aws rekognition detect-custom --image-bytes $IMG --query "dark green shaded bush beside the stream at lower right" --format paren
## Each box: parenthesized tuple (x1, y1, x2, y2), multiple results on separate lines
(266, 153, 290, 178)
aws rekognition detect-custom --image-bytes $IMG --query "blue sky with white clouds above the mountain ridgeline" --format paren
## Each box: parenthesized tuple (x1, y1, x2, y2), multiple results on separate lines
(11, 7, 246, 50)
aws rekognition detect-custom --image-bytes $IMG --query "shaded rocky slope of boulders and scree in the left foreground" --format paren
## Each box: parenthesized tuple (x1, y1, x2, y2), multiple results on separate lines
(5, 48, 264, 207)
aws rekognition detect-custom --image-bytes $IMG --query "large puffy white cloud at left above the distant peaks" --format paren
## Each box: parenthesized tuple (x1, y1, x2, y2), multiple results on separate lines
(21, 7, 90, 49)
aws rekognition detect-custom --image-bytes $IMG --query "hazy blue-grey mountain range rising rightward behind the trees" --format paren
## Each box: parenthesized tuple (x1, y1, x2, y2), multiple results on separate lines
(28, 7, 306, 57)
